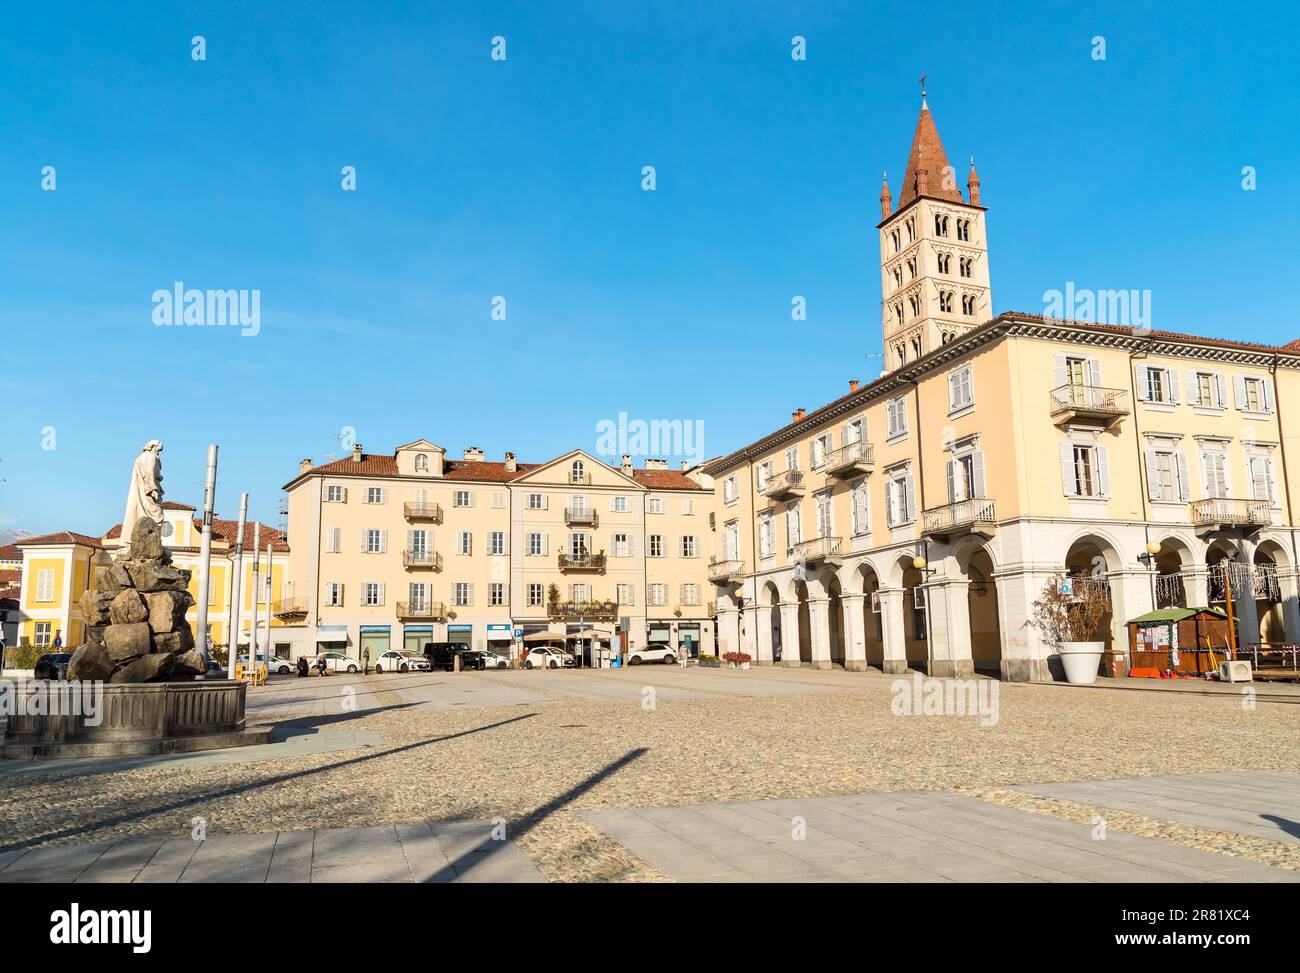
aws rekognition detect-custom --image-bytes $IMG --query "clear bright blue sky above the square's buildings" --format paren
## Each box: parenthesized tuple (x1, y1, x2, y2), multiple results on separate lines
(0, 1, 1300, 533)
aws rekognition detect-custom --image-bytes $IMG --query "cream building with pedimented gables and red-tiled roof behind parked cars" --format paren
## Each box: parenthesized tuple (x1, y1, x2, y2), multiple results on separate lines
(285, 440, 714, 665)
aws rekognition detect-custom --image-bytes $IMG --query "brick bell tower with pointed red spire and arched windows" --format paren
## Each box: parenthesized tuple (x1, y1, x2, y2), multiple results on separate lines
(876, 74, 993, 372)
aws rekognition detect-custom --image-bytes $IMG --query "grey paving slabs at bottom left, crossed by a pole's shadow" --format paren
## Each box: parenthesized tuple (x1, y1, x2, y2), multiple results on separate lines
(0, 821, 546, 883)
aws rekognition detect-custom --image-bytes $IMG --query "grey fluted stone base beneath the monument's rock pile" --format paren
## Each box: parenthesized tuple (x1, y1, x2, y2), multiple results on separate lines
(0, 679, 272, 760)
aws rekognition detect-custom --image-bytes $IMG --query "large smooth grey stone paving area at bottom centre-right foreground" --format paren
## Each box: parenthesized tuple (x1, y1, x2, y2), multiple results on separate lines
(587, 791, 1300, 882)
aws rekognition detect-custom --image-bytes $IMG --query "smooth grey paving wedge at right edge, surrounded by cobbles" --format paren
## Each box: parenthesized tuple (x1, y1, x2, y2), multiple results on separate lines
(1013, 771, 1300, 844)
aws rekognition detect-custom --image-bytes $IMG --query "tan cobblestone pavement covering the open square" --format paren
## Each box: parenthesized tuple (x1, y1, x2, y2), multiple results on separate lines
(0, 666, 1300, 881)
